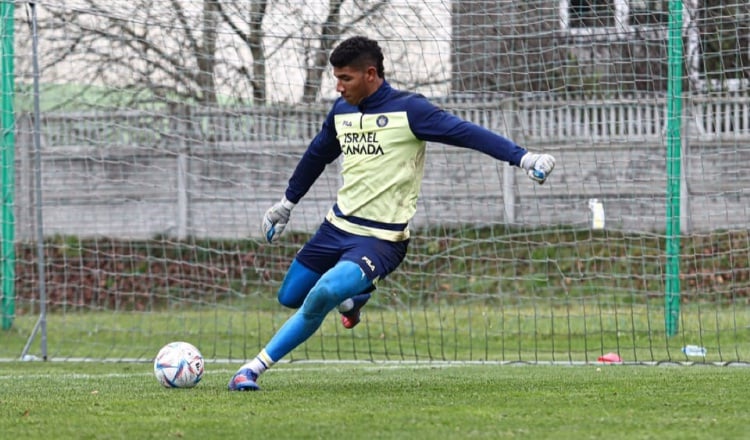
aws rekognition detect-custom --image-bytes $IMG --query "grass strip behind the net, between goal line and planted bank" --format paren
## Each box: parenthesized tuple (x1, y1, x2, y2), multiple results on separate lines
(5, 299, 750, 363)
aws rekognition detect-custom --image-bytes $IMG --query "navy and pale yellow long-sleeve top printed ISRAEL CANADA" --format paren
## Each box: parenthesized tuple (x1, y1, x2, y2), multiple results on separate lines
(285, 81, 527, 241)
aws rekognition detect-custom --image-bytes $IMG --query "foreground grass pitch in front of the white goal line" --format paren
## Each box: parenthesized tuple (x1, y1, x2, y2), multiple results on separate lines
(0, 362, 750, 439)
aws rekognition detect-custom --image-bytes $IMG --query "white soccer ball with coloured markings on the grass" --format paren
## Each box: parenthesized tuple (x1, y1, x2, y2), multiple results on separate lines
(154, 341, 204, 388)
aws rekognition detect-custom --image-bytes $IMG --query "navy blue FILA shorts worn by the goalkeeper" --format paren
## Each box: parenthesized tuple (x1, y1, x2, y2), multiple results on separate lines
(297, 220, 409, 283)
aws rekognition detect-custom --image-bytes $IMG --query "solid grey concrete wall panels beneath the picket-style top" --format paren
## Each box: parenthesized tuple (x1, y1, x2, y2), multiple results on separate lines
(15, 105, 750, 239)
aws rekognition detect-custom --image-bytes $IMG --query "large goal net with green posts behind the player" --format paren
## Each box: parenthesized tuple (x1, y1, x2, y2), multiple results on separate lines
(0, 0, 750, 364)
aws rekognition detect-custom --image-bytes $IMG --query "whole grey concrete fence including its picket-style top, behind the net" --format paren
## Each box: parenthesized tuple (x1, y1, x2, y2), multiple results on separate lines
(11, 94, 750, 241)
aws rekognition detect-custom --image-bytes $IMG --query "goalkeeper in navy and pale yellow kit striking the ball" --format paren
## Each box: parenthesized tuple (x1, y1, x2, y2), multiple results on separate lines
(229, 37, 555, 391)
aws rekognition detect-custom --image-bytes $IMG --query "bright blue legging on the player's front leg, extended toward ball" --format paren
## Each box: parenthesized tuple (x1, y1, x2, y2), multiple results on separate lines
(266, 261, 372, 362)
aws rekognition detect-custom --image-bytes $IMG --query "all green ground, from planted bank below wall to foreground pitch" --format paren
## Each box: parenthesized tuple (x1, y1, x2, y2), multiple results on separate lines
(0, 231, 750, 440)
